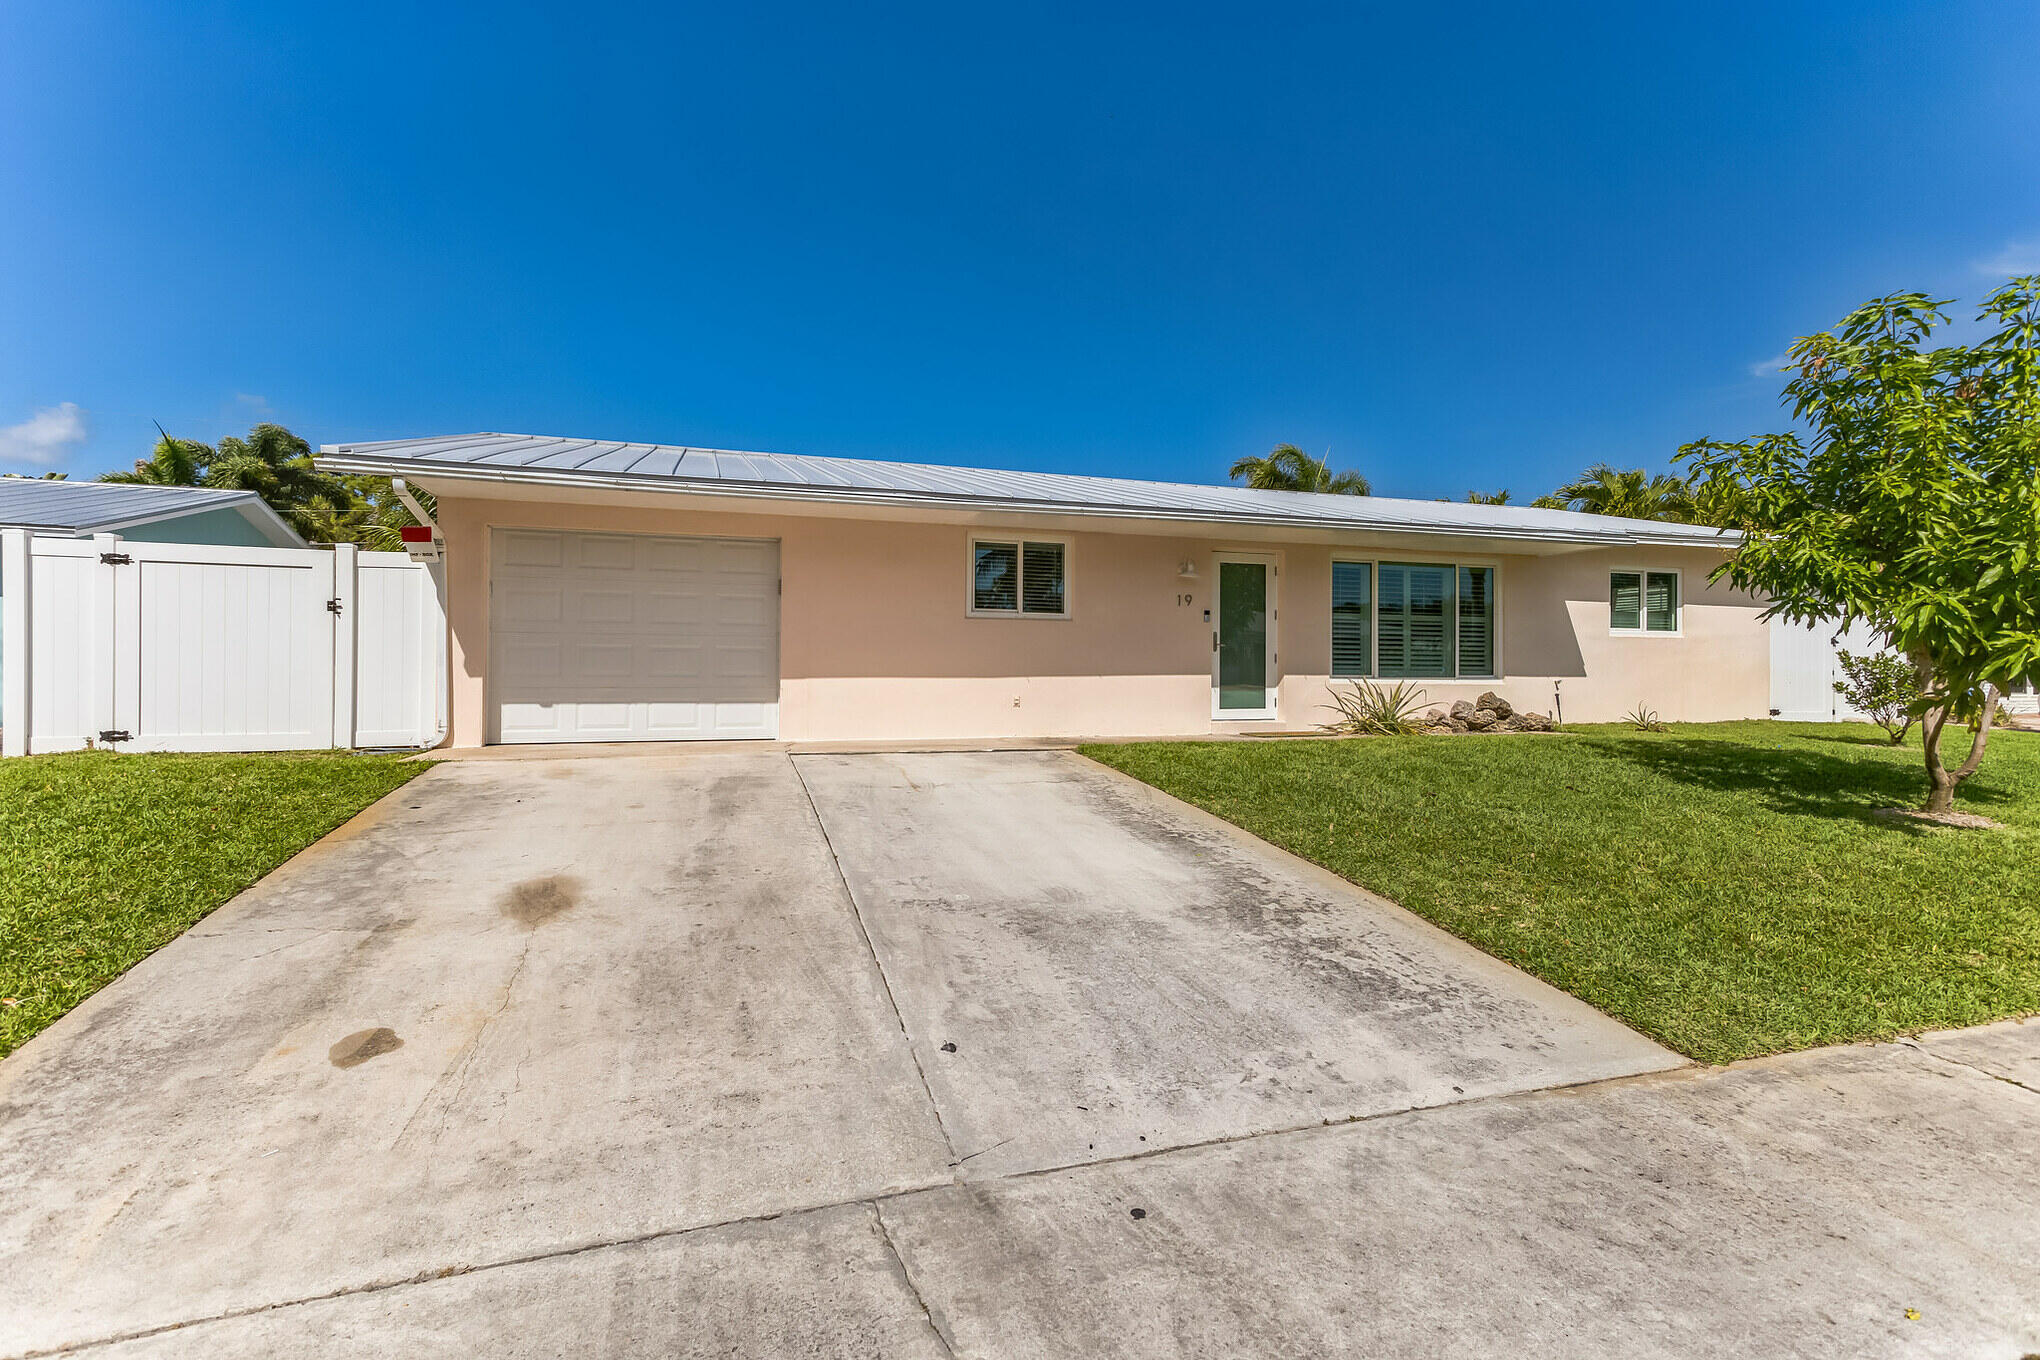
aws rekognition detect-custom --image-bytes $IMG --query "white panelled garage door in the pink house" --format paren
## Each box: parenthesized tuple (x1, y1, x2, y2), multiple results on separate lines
(490, 528, 779, 742)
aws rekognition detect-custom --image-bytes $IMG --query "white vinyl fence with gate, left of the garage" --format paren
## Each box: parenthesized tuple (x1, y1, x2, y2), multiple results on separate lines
(0, 530, 447, 756)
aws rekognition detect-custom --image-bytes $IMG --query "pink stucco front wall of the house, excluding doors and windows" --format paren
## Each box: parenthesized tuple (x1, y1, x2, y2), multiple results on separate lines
(439, 489, 1771, 746)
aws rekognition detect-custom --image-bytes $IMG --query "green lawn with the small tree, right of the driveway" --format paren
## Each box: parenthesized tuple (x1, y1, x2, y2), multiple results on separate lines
(1083, 722, 2040, 1062)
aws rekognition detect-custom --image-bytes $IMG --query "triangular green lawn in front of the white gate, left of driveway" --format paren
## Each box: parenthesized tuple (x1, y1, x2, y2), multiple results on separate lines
(0, 752, 426, 1056)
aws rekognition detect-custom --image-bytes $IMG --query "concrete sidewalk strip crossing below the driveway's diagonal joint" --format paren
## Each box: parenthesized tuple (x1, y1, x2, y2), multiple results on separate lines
(55, 1024, 2040, 1360)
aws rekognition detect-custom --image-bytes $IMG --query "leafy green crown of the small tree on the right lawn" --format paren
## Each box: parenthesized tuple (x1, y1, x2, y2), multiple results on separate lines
(1679, 275, 2040, 803)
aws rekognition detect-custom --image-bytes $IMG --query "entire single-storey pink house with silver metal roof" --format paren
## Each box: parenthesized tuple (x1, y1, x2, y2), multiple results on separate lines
(318, 434, 1771, 746)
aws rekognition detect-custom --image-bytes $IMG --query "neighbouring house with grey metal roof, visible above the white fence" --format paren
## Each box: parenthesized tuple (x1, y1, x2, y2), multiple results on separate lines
(0, 477, 306, 676)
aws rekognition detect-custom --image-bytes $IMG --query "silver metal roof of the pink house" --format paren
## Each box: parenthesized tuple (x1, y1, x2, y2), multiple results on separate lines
(318, 434, 1734, 544)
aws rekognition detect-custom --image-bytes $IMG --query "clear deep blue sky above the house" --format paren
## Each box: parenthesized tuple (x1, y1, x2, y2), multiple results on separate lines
(0, 0, 2040, 500)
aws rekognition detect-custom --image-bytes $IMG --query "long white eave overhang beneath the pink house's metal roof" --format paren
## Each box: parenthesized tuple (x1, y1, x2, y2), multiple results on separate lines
(318, 449, 1740, 551)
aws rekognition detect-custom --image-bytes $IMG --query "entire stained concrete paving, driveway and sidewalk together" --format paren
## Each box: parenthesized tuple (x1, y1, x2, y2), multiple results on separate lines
(0, 750, 2040, 1358)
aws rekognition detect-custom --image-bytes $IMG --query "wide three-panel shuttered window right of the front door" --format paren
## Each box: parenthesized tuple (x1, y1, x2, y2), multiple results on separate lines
(1332, 561, 1497, 679)
